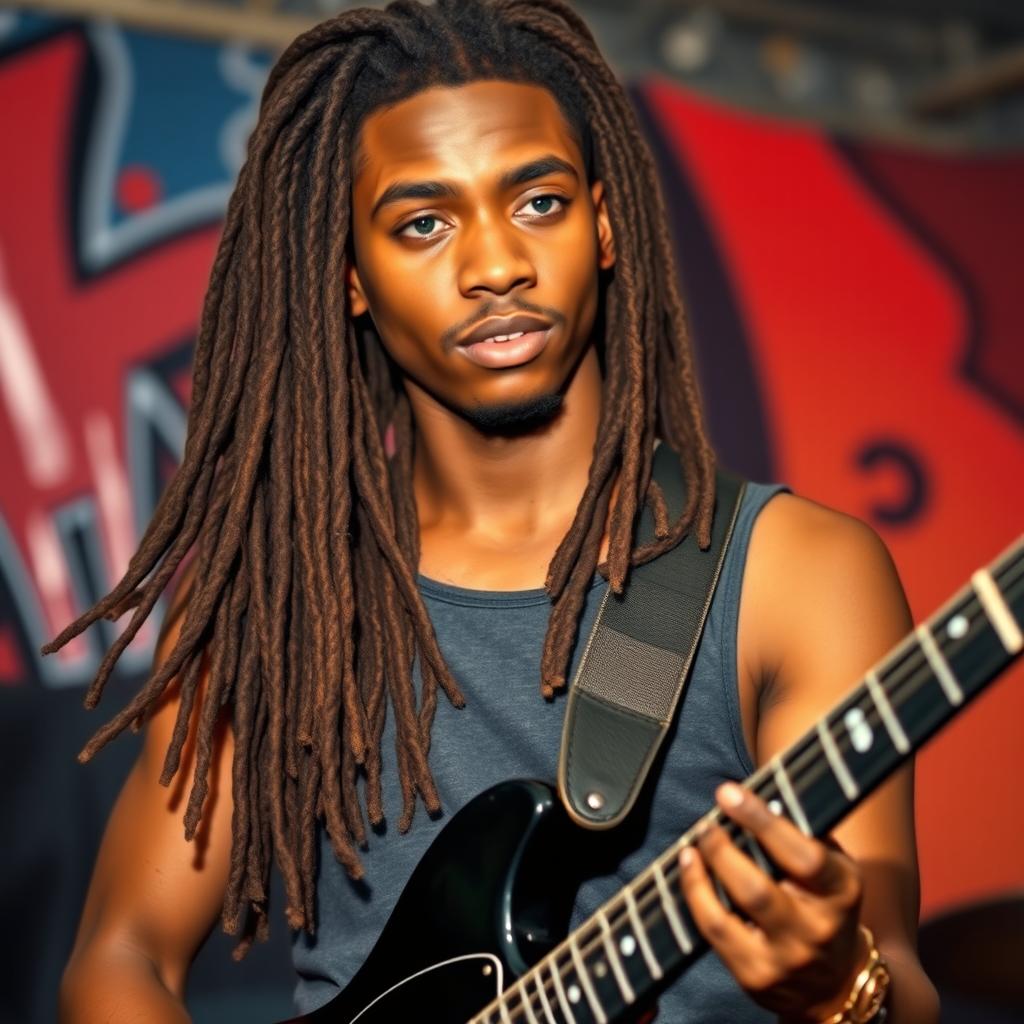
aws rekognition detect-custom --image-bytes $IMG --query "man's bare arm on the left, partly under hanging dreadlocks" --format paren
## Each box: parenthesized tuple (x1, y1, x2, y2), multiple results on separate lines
(59, 573, 233, 1024)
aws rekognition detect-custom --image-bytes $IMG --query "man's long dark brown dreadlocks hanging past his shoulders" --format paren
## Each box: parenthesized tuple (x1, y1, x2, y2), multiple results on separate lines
(43, 0, 714, 955)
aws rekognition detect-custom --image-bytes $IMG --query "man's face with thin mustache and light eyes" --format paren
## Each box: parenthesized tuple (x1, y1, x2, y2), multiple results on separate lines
(347, 81, 614, 425)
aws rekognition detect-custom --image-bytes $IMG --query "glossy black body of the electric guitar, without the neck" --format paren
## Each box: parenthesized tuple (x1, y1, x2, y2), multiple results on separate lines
(284, 780, 595, 1024)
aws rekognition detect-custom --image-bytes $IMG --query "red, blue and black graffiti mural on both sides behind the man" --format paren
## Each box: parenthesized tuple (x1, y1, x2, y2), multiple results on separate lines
(0, 11, 1024, 1020)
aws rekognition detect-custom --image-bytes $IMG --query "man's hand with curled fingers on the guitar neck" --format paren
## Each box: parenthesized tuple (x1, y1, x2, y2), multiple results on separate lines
(680, 782, 867, 1022)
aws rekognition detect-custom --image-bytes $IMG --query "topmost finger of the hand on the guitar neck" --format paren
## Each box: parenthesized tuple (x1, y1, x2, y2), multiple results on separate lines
(716, 782, 850, 895)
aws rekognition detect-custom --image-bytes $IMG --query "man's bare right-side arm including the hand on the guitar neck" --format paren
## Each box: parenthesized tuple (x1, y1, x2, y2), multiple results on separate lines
(683, 495, 938, 1024)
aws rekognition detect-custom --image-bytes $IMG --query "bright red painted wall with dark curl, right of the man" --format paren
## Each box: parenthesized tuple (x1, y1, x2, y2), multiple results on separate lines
(645, 82, 1024, 914)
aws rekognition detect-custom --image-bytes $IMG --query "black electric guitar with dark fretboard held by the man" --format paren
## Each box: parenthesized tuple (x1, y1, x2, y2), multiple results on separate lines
(282, 537, 1024, 1024)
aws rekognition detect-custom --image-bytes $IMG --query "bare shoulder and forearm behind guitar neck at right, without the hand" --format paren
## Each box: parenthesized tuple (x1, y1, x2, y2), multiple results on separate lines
(757, 496, 938, 1024)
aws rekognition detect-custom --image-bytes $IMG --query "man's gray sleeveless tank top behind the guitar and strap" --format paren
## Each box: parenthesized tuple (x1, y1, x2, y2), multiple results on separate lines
(292, 483, 785, 1024)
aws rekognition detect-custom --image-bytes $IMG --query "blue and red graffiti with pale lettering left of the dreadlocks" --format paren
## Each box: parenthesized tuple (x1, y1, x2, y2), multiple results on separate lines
(0, 15, 267, 686)
